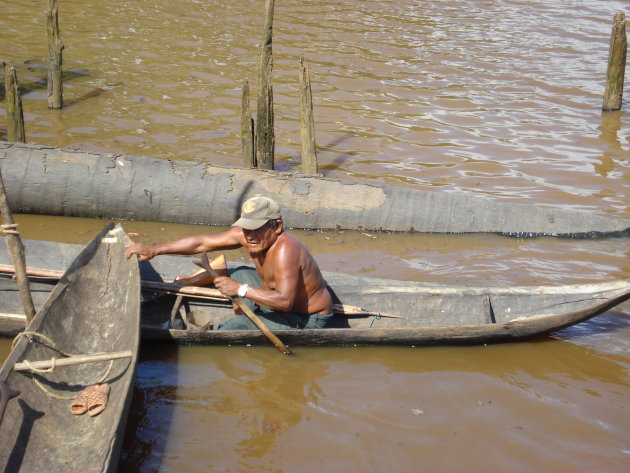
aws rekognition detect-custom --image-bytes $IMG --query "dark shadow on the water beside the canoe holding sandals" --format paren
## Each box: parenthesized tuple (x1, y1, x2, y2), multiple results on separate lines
(118, 344, 179, 473)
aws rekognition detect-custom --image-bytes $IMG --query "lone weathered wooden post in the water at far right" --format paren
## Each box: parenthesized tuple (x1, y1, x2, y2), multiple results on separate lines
(602, 12, 628, 112)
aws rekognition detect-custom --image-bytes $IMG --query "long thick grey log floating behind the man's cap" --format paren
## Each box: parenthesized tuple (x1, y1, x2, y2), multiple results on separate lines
(0, 141, 630, 237)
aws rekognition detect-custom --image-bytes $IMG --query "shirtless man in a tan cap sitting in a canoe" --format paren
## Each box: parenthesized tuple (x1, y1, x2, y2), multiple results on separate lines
(125, 197, 333, 330)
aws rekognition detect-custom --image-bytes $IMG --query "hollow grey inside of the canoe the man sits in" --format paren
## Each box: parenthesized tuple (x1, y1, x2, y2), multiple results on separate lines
(143, 278, 630, 329)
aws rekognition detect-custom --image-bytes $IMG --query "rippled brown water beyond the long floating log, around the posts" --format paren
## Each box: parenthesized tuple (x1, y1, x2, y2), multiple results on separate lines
(0, 0, 630, 218)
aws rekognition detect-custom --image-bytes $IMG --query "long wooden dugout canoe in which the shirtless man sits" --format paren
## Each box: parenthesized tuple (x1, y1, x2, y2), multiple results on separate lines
(0, 240, 630, 346)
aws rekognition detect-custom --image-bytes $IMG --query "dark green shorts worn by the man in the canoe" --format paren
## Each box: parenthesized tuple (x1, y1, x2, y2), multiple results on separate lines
(216, 266, 334, 330)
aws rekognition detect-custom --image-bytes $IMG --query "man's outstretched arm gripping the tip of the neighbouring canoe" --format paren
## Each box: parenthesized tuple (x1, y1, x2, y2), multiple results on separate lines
(125, 227, 245, 261)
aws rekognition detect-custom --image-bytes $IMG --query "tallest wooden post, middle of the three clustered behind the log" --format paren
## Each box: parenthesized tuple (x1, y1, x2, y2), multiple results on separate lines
(256, 0, 275, 169)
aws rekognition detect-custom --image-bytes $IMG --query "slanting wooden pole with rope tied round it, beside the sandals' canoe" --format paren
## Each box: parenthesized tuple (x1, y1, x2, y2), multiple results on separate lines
(0, 168, 35, 325)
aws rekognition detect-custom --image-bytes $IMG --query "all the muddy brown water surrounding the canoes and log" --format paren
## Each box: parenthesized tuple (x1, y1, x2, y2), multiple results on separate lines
(0, 0, 630, 473)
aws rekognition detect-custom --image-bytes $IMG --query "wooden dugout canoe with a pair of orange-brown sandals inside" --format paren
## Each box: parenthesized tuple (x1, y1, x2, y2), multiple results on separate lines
(0, 226, 140, 473)
